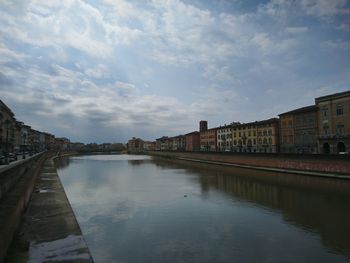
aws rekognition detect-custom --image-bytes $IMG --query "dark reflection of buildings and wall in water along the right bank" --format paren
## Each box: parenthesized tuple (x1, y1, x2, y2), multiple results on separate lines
(153, 159, 350, 253)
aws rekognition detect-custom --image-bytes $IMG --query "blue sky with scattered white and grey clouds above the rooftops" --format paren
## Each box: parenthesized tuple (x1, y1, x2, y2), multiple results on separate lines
(0, 0, 350, 143)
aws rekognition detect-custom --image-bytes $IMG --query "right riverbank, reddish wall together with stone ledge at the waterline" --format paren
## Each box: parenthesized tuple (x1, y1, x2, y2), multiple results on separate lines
(148, 152, 350, 179)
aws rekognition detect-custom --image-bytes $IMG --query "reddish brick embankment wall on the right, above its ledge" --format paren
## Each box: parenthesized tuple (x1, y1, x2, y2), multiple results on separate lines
(149, 152, 350, 176)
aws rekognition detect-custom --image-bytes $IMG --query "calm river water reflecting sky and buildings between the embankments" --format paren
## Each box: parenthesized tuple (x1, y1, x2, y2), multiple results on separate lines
(58, 155, 350, 263)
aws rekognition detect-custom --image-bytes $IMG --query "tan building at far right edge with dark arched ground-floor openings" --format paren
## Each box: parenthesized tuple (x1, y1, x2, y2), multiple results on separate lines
(315, 91, 350, 154)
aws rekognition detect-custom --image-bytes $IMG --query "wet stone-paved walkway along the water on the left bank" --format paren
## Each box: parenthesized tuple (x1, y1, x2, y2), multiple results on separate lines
(7, 159, 93, 263)
